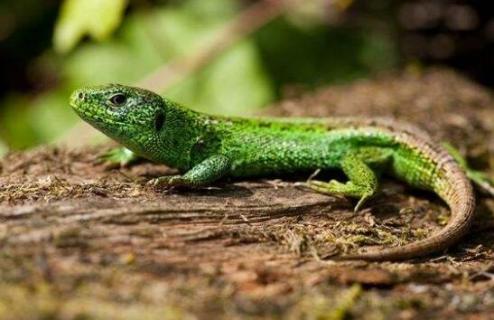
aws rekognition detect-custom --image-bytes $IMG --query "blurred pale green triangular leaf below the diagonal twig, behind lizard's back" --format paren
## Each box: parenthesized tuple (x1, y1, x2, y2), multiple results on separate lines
(165, 40, 274, 115)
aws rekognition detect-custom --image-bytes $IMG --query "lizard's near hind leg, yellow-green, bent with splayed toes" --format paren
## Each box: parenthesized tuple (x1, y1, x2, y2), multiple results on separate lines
(306, 148, 391, 211)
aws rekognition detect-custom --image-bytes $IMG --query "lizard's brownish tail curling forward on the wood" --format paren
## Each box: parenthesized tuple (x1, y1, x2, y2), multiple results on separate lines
(335, 153, 475, 261)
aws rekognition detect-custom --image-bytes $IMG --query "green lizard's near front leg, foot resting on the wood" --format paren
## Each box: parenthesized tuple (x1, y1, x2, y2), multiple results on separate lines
(150, 155, 231, 187)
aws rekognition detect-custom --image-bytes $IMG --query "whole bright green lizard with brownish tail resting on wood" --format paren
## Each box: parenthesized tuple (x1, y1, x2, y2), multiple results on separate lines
(71, 85, 492, 261)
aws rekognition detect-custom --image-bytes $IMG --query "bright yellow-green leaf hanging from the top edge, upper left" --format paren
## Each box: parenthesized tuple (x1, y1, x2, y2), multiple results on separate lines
(53, 0, 127, 53)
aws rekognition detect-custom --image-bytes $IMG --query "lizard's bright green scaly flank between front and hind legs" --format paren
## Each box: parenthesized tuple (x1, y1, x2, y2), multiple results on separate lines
(223, 128, 409, 181)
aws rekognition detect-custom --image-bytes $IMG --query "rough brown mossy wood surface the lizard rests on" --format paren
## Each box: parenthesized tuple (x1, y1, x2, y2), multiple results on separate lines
(0, 70, 494, 319)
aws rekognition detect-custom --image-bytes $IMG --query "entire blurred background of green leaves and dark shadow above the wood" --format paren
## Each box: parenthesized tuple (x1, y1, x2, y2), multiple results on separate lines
(0, 0, 494, 154)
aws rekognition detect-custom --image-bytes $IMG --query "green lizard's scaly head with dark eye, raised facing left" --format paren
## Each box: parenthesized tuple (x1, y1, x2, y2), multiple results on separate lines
(70, 84, 166, 154)
